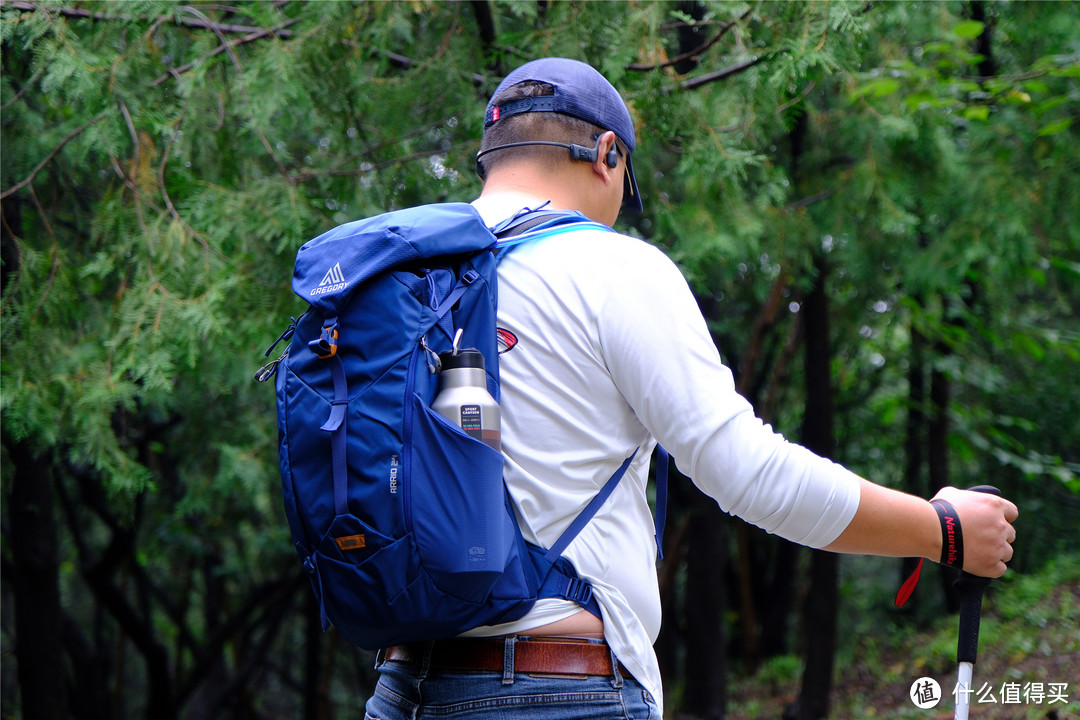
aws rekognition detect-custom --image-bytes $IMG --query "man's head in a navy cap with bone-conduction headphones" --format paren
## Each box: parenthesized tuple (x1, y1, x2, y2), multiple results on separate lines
(476, 57, 642, 212)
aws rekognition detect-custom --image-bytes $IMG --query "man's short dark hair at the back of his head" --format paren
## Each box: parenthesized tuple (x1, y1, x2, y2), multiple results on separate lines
(476, 80, 626, 180)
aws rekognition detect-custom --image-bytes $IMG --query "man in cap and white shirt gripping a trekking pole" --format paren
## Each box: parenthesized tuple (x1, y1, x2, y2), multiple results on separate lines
(368, 58, 1017, 719)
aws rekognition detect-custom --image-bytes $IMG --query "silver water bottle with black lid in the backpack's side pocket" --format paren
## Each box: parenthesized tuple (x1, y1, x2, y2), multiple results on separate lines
(431, 342, 502, 451)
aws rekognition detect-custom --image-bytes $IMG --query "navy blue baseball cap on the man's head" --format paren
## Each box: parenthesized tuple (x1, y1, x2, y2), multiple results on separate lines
(484, 57, 642, 213)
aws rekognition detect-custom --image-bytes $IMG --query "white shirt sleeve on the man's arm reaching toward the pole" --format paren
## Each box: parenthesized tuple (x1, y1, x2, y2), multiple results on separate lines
(598, 243, 859, 547)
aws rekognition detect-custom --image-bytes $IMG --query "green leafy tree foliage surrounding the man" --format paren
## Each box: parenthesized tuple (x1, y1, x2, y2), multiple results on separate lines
(0, 0, 1080, 715)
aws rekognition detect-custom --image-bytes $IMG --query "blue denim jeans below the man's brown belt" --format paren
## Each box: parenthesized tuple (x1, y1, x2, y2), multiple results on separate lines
(364, 641, 660, 720)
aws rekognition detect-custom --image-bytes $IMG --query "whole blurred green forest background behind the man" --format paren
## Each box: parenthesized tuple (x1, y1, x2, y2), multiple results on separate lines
(0, 0, 1080, 720)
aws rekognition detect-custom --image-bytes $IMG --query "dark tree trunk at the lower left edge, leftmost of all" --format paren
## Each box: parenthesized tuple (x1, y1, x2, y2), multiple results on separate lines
(4, 438, 69, 720)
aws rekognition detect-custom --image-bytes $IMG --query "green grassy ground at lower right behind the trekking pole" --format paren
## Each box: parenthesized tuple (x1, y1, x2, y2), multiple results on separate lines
(728, 554, 1080, 720)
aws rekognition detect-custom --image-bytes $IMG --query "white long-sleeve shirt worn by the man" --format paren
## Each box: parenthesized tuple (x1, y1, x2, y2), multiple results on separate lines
(469, 194, 859, 709)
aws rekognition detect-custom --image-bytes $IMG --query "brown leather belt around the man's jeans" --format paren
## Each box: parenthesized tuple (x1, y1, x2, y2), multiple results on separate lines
(386, 637, 625, 677)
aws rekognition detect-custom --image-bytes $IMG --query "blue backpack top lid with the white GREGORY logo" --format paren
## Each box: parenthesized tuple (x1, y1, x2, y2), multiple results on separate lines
(293, 203, 496, 316)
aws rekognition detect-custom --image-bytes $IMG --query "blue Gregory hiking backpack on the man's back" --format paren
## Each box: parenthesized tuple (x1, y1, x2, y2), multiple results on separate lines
(256, 203, 667, 650)
